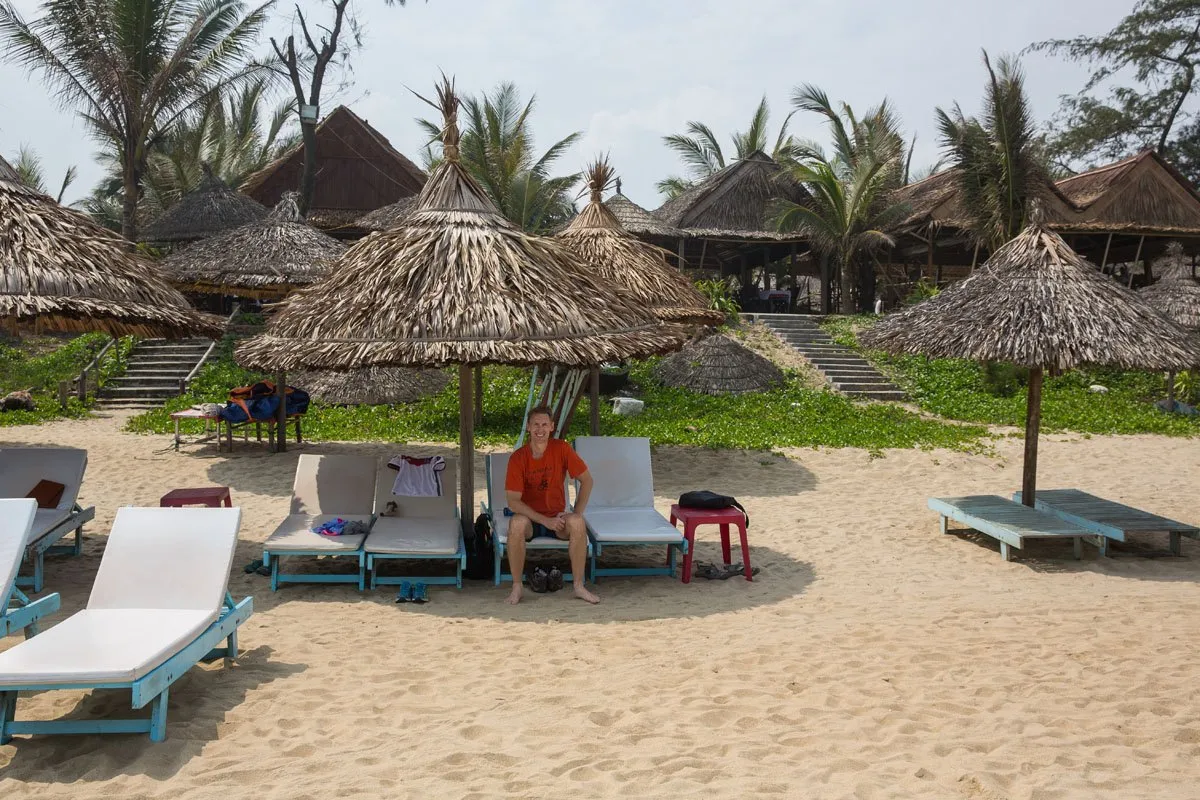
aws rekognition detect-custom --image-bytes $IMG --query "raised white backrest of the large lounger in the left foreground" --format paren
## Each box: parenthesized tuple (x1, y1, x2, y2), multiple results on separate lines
(88, 507, 241, 614)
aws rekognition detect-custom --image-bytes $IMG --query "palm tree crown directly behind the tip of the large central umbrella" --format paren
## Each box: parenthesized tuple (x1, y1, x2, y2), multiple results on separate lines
(416, 83, 582, 233)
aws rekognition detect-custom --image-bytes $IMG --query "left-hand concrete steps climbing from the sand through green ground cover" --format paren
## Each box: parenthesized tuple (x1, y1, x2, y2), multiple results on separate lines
(96, 339, 212, 409)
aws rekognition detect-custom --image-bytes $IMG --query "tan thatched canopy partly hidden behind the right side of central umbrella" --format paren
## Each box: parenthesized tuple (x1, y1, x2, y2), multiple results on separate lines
(557, 160, 725, 325)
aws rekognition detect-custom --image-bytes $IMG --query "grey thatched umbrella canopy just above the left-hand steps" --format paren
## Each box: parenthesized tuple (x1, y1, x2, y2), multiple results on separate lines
(163, 192, 346, 299)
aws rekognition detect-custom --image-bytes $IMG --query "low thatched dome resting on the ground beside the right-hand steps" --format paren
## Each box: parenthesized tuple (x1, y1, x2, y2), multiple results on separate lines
(654, 333, 784, 395)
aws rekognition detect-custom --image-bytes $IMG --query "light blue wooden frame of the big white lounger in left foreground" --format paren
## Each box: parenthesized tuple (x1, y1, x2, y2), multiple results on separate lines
(0, 593, 254, 745)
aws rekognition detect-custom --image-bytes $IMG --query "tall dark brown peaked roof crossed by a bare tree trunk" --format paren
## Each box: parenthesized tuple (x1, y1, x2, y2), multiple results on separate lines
(241, 106, 426, 239)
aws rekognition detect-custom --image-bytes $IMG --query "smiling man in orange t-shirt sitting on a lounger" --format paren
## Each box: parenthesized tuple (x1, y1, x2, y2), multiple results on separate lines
(504, 405, 600, 604)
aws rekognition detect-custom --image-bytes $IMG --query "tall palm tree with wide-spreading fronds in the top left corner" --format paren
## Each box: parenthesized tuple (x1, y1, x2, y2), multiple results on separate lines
(0, 0, 270, 241)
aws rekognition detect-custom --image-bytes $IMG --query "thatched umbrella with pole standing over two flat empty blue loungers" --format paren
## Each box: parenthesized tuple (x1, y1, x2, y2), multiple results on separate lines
(862, 223, 1195, 506)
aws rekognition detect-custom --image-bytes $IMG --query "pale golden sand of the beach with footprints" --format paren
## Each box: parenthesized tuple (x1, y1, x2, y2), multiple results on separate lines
(0, 417, 1200, 800)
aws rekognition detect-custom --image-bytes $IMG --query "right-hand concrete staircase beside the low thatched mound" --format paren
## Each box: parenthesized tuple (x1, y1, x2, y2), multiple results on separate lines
(754, 314, 905, 401)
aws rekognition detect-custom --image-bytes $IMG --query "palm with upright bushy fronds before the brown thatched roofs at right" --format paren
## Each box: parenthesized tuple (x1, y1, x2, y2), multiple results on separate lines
(937, 50, 1052, 252)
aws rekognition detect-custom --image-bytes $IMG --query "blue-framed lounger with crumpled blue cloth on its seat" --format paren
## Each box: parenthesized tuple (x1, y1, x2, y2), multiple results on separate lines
(263, 453, 376, 591)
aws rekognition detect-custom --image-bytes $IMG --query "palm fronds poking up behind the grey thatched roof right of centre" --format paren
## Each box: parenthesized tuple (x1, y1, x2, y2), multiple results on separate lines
(655, 95, 796, 198)
